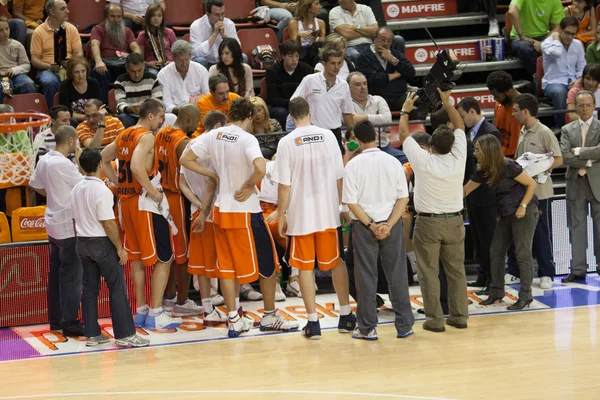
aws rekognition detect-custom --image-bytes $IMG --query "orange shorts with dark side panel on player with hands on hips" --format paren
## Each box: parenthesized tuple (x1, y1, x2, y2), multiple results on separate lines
(213, 207, 279, 284)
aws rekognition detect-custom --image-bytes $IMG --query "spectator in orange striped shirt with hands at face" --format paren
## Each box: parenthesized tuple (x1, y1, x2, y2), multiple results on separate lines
(77, 99, 125, 147)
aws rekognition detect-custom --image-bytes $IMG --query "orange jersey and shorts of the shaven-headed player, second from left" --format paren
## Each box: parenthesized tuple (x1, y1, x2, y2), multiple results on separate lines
(154, 126, 190, 264)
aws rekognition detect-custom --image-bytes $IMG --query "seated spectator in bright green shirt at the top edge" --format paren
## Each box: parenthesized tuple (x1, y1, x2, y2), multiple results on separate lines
(508, 0, 565, 75)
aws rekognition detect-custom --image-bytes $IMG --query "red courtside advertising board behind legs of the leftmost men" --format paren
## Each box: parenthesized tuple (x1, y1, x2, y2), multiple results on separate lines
(0, 244, 150, 328)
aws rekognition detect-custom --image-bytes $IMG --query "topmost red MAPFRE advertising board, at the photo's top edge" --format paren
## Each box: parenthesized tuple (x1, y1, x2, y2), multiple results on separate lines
(383, 0, 456, 20)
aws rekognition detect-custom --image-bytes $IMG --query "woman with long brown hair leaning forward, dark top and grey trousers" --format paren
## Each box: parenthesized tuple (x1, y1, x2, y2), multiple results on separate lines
(464, 134, 539, 310)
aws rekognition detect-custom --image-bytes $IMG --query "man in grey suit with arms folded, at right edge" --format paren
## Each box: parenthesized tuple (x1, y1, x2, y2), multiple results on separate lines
(560, 90, 600, 282)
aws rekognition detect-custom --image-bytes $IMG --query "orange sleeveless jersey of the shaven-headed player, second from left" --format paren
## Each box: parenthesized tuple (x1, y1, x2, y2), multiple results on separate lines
(154, 126, 188, 193)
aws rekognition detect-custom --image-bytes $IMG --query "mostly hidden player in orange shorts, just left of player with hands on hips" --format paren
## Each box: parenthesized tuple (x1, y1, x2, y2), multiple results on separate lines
(179, 110, 227, 327)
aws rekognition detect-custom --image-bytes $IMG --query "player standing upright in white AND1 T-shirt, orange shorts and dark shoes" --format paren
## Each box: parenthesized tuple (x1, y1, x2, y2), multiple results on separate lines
(273, 97, 356, 339)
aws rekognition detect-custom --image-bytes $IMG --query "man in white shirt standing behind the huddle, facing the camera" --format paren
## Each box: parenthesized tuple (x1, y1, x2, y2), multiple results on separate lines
(286, 48, 354, 148)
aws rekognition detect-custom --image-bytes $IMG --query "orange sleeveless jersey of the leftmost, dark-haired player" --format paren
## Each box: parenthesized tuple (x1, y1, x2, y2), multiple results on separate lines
(117, 126, 158, 199)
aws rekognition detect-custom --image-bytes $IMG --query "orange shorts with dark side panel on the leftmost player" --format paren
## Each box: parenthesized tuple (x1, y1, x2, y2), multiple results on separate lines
(119, 196, 173, 267)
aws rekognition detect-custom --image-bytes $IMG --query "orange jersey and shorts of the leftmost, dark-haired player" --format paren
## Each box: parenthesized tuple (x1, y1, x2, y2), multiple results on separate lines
(117, 126, 173, 266)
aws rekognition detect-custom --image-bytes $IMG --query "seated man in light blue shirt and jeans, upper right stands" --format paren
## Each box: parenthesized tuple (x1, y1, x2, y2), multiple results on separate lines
(542, 17, 585, 127)
